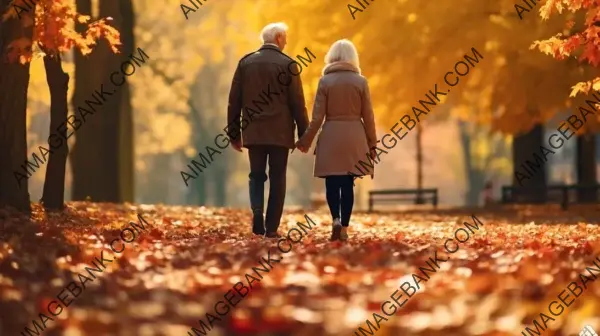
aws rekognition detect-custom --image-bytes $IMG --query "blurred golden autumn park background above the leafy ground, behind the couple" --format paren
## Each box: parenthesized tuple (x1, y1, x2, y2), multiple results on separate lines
(12, 0, 600, 209)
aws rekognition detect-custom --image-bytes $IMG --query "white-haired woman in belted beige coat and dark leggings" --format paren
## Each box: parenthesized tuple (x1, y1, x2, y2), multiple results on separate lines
(296, 39, 377, 240)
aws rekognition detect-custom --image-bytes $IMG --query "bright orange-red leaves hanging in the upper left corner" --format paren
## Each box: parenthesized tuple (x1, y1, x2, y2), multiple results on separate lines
(2, 0, 121, 63)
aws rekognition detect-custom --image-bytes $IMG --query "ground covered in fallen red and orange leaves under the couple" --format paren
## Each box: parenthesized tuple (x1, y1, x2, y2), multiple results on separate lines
(0, 202, 600, 336)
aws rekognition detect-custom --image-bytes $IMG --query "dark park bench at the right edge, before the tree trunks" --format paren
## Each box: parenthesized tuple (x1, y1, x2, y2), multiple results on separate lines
(502, 184, 600, 210)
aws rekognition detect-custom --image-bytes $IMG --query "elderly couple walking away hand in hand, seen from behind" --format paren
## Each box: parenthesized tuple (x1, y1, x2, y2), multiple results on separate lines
(227, 23, 377, 240)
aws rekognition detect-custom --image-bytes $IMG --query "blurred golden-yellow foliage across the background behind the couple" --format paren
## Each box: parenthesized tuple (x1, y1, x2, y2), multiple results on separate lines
(23, 0, 600, 168)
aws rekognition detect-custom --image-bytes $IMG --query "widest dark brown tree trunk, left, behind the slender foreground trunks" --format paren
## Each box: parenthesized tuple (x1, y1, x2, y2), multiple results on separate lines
(72, 0, 137, 202)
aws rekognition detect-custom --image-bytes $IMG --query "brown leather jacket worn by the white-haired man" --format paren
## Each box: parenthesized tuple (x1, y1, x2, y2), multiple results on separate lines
(226, 44, 308, 149)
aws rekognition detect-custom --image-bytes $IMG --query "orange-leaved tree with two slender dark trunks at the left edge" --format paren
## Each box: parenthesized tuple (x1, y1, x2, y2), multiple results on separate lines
(0, 0, 119, 212)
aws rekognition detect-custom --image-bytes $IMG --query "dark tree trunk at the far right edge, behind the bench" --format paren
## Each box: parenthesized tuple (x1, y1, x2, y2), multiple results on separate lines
(576, 134, 598, 203)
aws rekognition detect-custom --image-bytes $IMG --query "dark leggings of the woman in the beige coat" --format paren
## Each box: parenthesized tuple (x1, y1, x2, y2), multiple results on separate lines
(325, 175, 354, 227)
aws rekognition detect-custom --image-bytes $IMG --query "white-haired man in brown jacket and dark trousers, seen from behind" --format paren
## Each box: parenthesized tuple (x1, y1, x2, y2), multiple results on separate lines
(227, 23, 308, 238)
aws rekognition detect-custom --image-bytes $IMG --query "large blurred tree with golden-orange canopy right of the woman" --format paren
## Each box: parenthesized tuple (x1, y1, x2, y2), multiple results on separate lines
(254, 0, 589, 200)
